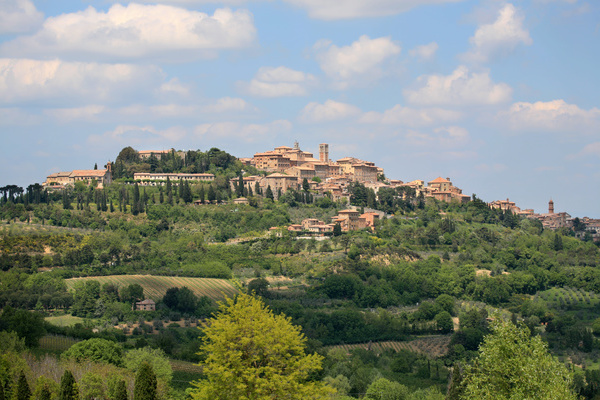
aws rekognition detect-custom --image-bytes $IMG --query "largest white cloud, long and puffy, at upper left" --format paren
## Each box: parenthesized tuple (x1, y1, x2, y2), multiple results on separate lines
(2, 4, 256, 60)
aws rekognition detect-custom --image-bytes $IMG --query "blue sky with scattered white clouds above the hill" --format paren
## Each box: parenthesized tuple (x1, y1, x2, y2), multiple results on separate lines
(0, 0, 600, 218)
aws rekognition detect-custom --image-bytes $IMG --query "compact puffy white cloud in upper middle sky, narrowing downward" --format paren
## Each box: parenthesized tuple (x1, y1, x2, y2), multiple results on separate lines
(315, 35, 401, 88)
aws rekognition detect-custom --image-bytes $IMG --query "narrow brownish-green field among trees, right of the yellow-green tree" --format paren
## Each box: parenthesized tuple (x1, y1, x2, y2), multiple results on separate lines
(330, 336, 450, 358)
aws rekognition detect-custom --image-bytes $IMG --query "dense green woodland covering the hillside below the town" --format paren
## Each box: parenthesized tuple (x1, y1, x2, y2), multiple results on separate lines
(0, 148, 600, 400)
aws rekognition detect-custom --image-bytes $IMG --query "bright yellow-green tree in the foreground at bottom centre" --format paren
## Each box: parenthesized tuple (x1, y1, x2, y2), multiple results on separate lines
(191, 294, 332, 400)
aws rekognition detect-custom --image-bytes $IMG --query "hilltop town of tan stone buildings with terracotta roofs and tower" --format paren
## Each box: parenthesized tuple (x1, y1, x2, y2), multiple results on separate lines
(43, 142, 600, 241)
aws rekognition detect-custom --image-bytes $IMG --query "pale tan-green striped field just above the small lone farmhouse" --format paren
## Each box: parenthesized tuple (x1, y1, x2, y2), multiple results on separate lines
(66, 275, 238, 301)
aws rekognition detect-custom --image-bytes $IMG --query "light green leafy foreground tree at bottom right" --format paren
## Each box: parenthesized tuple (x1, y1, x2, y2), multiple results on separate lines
(462, 316, 577, 400)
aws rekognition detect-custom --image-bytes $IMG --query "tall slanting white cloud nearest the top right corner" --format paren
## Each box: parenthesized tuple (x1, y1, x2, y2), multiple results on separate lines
(463, 4, 533, 63)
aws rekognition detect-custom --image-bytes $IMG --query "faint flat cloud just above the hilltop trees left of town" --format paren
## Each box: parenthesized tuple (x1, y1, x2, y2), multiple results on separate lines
(88, 125, 187, 146)
